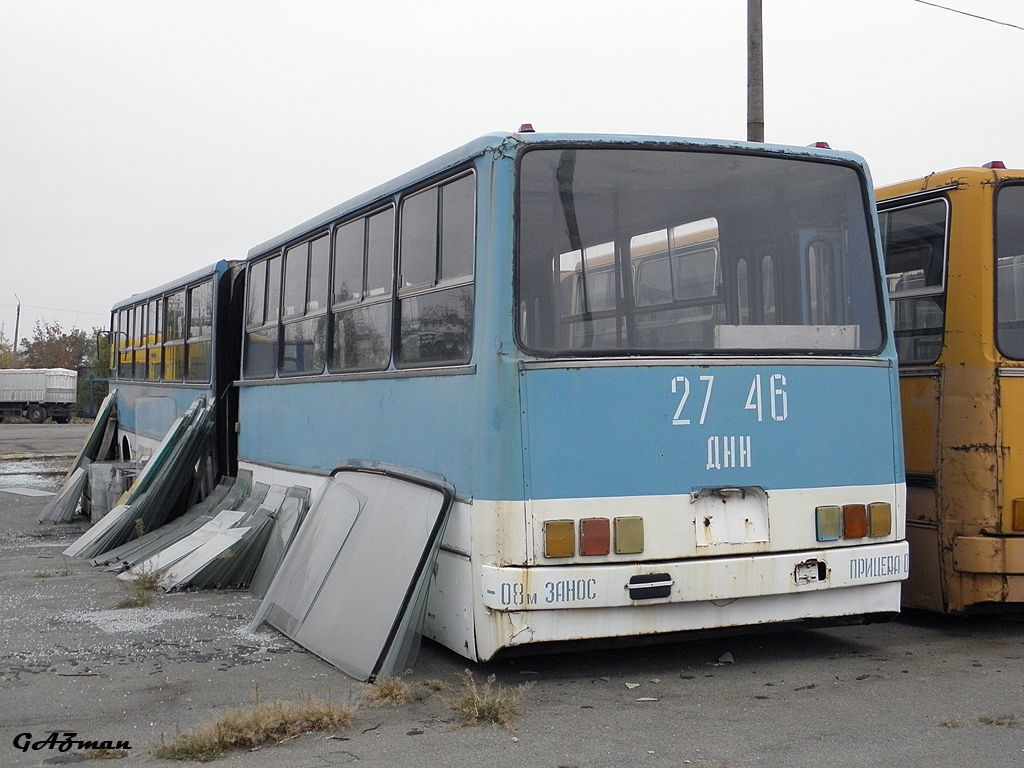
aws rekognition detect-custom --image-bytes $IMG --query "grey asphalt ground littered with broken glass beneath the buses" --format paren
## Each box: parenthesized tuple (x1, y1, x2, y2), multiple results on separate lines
(0, 425, 1024, 768)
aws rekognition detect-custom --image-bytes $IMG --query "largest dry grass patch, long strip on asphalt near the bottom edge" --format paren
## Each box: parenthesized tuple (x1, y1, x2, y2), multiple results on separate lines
(152, 695, 352, 763)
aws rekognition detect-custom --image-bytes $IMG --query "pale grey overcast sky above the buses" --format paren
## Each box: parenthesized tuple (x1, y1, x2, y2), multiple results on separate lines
(0, 0, 1024, 339)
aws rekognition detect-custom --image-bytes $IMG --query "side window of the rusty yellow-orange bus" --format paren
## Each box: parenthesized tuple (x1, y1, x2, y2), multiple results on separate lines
(879, 198, 949, 365)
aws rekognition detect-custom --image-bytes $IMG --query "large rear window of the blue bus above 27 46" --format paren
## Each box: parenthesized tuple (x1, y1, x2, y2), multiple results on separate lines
(516, 148, 883, 356)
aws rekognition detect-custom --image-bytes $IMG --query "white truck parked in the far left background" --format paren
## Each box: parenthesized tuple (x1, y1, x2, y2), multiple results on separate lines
(0, 368, 78, 424)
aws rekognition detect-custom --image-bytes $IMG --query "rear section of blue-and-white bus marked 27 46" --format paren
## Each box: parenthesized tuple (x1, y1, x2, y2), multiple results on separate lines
(238, 130, 907, 660)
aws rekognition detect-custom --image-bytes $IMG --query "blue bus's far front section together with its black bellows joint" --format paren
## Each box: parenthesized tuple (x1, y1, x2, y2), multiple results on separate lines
(111, 261, 243, 476)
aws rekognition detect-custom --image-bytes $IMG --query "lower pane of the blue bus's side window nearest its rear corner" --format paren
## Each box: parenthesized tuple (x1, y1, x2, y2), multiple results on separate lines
(397, 286, 473, 368)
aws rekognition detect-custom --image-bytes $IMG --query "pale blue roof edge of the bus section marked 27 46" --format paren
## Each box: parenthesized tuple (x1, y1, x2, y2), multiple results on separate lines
(247, 132, 871, 259)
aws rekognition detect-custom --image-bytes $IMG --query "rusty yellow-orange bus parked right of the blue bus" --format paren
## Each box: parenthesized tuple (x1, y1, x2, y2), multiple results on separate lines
(877, 163, 1024, 613)
